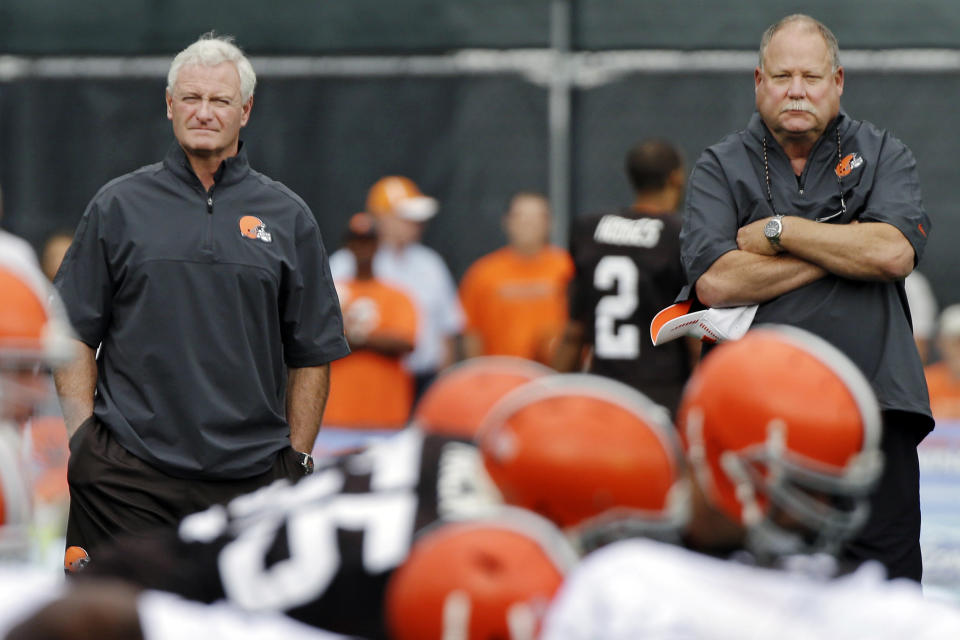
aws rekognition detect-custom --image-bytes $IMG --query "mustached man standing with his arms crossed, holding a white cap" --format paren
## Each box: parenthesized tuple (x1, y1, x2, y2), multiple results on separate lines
(681, 15, 933, 581)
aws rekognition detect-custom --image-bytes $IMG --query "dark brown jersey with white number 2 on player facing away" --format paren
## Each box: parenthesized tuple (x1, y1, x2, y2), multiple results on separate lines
(570, 209, 690, 410)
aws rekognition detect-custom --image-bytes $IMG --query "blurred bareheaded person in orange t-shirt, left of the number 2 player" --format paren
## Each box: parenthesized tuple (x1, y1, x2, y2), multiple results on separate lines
(460, 192, 573, 363)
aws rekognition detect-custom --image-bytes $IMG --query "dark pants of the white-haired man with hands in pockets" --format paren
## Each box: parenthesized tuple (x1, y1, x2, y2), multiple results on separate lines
(67, 418, 303, 558)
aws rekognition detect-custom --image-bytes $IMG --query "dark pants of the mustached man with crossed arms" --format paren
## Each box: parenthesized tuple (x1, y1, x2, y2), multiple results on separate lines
(843, 411, 929, 582)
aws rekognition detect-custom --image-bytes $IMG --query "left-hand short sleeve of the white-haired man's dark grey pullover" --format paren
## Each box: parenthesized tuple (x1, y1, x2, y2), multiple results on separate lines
(54, 199, 115, 349)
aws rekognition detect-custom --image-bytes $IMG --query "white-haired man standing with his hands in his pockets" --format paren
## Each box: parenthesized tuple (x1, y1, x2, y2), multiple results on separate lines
(55, 35, 349, 561)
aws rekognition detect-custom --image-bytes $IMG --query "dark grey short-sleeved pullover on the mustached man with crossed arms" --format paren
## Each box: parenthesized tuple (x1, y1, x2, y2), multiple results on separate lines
(680, 111, 933, 427)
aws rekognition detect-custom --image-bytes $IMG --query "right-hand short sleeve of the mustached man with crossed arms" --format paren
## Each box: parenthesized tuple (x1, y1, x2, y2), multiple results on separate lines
(860, 134, 931, 265)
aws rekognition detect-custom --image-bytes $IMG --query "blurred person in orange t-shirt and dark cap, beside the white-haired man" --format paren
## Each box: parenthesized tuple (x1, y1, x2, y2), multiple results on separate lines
(321, 213, 417, 435)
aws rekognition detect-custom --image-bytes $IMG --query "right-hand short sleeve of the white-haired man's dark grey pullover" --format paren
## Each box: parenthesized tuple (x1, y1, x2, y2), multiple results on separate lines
(279, 211, 350, 367)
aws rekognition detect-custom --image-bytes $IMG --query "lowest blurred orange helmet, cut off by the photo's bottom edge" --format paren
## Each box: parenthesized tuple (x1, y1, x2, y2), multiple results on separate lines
(385, 510, 574, 640)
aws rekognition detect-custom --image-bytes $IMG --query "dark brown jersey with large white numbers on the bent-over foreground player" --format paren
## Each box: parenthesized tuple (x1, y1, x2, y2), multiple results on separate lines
(79, 429, 497, 639)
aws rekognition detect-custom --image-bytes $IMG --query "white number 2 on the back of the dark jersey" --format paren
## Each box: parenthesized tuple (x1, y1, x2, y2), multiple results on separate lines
(593, 256, 640, 360)
